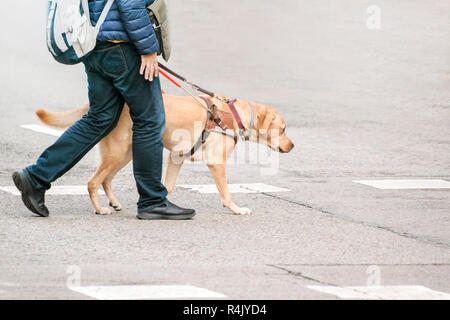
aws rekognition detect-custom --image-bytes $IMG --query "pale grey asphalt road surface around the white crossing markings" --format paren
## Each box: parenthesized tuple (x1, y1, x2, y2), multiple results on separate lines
(0, 0, 450, 299)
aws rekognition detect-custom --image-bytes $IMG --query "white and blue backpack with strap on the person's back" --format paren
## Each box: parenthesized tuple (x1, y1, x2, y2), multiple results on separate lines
(47, 0, 114, 65)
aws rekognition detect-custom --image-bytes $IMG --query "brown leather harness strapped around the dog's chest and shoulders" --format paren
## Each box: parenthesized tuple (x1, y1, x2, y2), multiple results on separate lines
(183, 96, 254, 158)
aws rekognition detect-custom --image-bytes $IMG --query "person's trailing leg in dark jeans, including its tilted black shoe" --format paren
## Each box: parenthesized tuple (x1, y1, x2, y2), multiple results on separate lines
(13, 59, 124, 216)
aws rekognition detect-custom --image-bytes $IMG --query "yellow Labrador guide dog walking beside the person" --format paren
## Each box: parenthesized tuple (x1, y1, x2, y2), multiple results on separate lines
(36, 94, 294, 215)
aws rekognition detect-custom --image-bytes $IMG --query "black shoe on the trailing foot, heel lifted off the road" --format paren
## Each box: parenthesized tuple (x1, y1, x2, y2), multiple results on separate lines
(13, 170, 49, 217)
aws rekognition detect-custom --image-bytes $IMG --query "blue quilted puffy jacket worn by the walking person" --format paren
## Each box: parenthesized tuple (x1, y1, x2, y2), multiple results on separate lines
(89, 0, 159, 55)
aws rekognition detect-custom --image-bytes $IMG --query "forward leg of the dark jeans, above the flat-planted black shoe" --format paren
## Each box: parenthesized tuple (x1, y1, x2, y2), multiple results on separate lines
(114, 44, 167, 212)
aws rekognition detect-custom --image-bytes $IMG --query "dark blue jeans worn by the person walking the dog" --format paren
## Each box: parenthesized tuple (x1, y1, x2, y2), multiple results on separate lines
(26, 42, 167, 212)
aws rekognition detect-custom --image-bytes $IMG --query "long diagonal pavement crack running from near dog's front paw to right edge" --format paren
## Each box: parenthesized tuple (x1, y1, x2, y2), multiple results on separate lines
(261, 192, 450, 249)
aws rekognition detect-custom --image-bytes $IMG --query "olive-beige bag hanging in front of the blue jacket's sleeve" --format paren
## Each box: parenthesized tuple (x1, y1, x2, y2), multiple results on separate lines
(147, 0, 172, 61)
